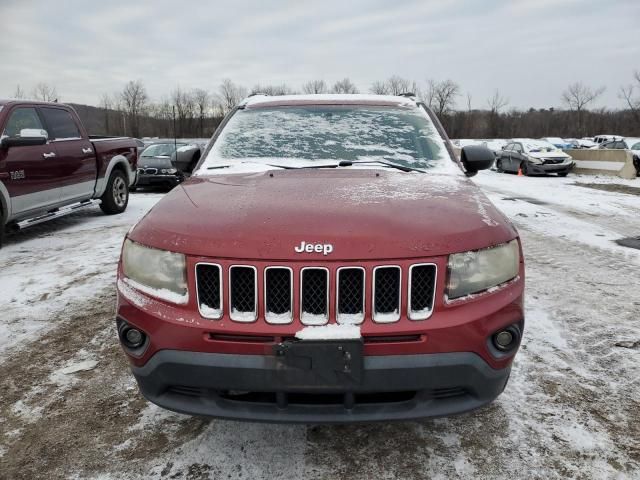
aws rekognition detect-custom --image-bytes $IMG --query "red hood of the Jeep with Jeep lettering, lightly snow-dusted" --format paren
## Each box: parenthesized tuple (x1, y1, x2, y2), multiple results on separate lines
(129, 169, 517, 261)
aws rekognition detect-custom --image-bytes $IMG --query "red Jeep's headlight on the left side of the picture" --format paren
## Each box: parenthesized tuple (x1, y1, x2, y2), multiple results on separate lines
(122, 239, 189, 303)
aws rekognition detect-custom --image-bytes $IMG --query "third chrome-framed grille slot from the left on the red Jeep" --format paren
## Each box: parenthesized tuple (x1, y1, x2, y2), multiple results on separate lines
(264, 267, 293, 324)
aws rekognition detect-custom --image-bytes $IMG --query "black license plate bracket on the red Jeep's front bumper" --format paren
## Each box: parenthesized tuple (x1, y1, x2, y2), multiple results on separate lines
(274, 340, 364, 388)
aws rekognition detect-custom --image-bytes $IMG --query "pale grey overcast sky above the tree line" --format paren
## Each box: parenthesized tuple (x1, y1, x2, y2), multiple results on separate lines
(0, 0, 640, 108)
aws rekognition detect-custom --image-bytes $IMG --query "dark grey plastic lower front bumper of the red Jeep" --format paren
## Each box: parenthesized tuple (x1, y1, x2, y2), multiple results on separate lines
(132, 350, 510, 423)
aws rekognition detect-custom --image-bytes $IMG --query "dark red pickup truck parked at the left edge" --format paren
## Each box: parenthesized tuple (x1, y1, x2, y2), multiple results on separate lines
(0, 100, 138, 245)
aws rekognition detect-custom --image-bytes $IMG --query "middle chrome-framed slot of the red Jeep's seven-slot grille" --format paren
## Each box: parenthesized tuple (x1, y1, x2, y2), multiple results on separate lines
(300, 267, 329, 325)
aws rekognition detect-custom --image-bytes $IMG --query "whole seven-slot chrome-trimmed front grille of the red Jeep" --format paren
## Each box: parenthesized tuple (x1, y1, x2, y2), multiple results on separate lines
(195, 262, 437, 325)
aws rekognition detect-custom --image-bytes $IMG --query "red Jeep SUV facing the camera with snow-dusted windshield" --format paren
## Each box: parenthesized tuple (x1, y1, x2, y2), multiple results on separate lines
(116, 95, 524, 423)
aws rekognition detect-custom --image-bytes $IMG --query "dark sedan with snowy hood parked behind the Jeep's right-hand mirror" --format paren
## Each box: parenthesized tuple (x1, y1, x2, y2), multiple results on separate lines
(496, 138, 575, 177)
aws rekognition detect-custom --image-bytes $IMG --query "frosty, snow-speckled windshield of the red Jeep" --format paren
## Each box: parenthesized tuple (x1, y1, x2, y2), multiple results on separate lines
(200, 105, 459, 172)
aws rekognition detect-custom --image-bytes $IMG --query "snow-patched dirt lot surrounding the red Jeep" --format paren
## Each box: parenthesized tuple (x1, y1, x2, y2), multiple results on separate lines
(0, 172, 640, 480)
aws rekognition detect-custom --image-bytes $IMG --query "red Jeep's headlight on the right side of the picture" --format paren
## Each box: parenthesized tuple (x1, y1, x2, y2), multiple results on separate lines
(447, 240, 520, 299)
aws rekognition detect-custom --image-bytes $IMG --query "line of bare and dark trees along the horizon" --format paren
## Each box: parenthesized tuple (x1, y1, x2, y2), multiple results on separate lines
(13, 71, 640, 138)
